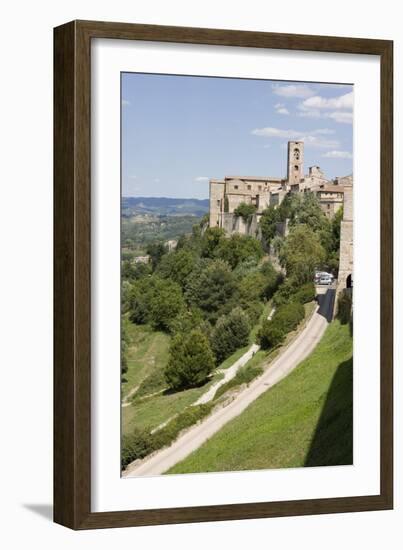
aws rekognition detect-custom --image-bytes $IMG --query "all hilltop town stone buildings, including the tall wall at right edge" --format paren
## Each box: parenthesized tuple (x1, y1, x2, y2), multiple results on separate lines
(209, 141, 353, 294)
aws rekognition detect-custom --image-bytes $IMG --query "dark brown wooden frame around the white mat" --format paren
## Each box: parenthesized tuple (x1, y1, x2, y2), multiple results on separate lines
(54, 21, 393, 529)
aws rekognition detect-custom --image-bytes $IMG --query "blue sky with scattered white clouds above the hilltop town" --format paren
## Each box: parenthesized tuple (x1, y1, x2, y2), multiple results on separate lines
(122, 73, 353, 199)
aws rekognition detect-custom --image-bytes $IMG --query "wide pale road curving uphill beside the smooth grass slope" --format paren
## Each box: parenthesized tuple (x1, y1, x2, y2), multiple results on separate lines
(122, 287, 335, 477)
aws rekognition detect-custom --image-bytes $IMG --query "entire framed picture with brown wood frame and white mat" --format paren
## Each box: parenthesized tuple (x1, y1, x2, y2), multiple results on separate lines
(54, 21, 393, 529)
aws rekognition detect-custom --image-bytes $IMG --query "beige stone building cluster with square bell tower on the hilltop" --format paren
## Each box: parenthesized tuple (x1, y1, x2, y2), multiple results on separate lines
(210, 141, 352, 236)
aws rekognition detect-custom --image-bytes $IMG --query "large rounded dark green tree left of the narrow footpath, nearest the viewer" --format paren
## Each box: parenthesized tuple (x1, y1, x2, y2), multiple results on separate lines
(164, 329, 215, 390)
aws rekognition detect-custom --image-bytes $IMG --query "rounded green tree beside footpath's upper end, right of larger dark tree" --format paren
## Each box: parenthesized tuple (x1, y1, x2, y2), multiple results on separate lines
(211, 307, 250, 363)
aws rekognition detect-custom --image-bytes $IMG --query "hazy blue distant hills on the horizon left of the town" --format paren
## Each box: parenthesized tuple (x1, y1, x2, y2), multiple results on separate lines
(122, 197, 209, 217)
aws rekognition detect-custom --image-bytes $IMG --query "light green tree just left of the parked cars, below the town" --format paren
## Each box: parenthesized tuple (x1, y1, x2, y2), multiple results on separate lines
(280, 225, 325, 284)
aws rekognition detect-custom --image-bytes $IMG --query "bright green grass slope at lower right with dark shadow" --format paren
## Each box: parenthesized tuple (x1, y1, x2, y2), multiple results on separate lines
(169, 321, 352, 473)
